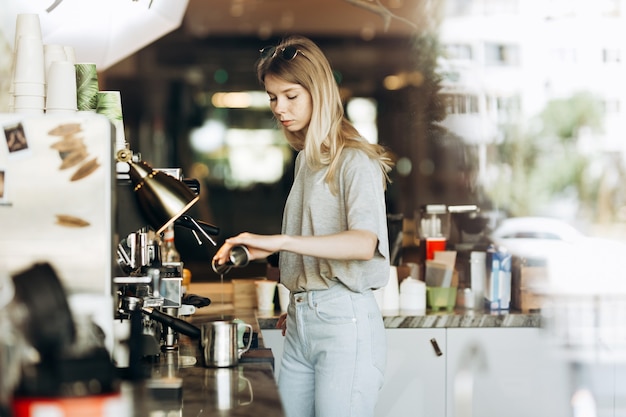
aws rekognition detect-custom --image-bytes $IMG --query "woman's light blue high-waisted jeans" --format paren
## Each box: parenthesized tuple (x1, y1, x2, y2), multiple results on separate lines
(278, 285, 387, 417)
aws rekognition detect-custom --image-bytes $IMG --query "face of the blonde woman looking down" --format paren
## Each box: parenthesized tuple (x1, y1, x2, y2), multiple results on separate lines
(264, 75, 313, 132)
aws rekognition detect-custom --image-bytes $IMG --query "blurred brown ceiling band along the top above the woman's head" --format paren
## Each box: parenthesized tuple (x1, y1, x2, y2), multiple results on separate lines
(183, 0, 430, 39)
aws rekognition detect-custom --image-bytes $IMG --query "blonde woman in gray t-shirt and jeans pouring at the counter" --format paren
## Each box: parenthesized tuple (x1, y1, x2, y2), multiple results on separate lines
(214, 37, 392, 417)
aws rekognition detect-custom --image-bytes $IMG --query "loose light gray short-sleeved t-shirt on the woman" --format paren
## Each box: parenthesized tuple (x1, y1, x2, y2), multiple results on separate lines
(280, 148, 390, 292)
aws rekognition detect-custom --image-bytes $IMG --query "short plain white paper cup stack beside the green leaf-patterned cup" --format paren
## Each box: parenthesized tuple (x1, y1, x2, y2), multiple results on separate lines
(46, 61, 76, 111)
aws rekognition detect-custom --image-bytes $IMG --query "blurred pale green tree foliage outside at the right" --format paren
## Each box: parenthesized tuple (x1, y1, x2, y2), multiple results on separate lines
(488, 92, 603, 216)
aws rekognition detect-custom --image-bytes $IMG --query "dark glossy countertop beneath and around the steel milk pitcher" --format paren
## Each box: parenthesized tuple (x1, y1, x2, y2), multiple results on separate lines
(122, 309, 284, 417)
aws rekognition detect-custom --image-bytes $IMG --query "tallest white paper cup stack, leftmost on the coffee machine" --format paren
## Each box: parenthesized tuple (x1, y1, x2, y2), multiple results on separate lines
(10, 13, 45, 114)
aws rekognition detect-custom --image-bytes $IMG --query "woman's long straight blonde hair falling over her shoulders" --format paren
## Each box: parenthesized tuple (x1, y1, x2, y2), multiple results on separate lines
(257, 36, 393, 192)
